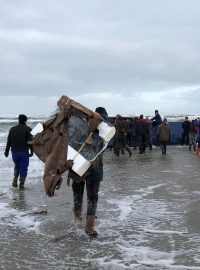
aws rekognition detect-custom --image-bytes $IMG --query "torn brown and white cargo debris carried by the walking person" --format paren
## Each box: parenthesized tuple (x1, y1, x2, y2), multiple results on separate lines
(32, 96, 115, 196)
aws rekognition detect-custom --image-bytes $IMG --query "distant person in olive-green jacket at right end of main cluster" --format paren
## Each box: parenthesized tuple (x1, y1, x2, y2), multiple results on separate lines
(157, 118, 171, 155)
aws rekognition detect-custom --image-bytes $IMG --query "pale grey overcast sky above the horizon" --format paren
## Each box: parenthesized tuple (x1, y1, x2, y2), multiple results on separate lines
(0, 0, 200, 115)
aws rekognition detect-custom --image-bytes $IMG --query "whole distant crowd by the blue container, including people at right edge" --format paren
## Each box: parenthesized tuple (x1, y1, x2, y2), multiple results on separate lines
(108, 110, 200, 156)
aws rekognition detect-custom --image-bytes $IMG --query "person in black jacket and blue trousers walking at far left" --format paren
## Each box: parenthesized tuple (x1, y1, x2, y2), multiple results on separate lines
(4, 114, 33, 189)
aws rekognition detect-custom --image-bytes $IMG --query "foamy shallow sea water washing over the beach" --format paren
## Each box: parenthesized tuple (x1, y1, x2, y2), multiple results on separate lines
(0, 116, 200, 270)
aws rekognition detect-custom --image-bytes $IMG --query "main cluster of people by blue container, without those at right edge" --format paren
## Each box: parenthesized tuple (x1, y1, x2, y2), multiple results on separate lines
(108, 110, 171, 157)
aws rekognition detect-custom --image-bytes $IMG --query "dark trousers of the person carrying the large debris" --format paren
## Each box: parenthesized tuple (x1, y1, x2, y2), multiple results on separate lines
(72, 180, 100, 216)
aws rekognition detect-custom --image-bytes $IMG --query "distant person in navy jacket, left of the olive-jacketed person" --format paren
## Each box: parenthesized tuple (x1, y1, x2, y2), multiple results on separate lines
(135, 114, 149, 154)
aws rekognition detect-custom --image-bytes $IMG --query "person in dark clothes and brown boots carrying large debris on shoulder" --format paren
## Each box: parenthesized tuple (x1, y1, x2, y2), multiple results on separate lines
(68, 107, 108, 237)
